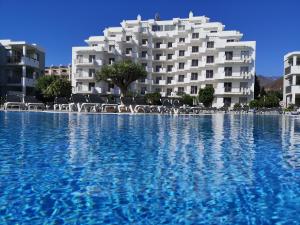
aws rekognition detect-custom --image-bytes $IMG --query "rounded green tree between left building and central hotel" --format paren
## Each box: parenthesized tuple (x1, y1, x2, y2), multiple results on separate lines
(35, 76, 72, 101)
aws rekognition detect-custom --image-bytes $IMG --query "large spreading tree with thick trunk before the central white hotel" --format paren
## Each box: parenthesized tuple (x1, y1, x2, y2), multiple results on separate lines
(96, 60, 147, 97)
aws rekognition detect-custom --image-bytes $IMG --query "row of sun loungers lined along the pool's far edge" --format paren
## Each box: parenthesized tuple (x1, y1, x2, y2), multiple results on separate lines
(4, 94, 288, 114)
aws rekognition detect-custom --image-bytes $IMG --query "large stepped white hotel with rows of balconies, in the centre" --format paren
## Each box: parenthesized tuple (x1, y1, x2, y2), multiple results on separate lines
(72, 12, 256, 107)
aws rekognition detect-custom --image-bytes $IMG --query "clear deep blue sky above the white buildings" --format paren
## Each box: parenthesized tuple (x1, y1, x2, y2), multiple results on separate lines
(0, 0, 300, 75)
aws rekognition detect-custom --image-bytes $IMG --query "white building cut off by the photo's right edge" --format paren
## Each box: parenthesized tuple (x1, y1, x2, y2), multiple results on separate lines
(283, 51, 300, 107)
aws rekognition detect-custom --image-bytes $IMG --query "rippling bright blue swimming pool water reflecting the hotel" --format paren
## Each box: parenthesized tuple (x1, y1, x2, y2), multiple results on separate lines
(0, 112, 300, 224)
